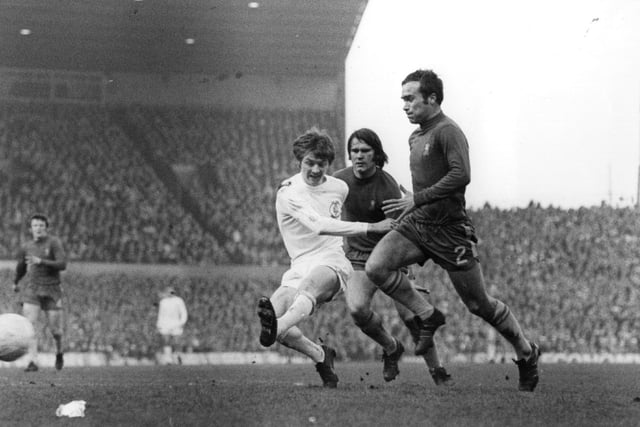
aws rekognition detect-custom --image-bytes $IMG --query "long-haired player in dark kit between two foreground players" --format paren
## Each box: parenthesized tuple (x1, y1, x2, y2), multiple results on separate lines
(334, 128, 451, 385)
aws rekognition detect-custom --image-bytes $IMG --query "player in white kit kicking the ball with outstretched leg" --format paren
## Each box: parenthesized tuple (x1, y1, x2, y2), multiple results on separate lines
(258, 128, 393, 388)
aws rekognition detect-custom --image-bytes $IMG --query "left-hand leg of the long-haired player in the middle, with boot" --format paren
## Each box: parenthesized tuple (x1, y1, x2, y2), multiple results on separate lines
(345, 269, 404, 381)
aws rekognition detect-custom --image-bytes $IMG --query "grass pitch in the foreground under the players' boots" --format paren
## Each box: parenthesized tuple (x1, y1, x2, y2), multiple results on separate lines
(0, 362, 640, 426)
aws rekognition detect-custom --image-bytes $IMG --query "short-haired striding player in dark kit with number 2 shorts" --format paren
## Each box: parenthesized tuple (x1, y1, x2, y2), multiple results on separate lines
(365, 70, 540, 391)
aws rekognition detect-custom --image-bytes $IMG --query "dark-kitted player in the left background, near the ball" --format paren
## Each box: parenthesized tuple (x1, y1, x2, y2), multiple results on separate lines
(13, 214, 67, 372)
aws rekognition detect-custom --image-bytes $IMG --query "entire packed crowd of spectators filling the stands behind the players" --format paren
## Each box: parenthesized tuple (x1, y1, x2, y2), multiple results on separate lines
(0, 104, 640, 358)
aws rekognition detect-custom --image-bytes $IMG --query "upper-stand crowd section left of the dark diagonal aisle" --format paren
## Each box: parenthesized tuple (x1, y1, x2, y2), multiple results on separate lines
(0, 104, 227, 263)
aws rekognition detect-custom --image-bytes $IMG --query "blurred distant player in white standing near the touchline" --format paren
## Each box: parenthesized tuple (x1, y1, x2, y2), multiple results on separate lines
(156, 287, 189, 365)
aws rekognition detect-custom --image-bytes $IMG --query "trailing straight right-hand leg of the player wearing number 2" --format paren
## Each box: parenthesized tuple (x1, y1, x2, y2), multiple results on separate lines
(448, 263, 540, 391)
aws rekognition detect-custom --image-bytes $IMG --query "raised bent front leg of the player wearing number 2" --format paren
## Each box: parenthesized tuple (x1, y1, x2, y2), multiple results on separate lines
(365, 230, 445, 355)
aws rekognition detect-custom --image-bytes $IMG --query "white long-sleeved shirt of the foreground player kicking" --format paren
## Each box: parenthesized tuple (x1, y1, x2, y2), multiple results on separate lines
(276, 173, 368, 265)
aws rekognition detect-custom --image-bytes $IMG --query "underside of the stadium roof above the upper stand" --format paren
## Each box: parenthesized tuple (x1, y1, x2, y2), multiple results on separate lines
(0, 0, 367, 76)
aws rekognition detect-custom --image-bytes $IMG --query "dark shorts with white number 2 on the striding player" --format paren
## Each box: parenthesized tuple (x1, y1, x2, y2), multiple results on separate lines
(395, 216, 478, 271)
